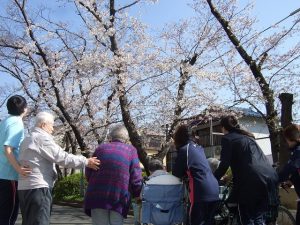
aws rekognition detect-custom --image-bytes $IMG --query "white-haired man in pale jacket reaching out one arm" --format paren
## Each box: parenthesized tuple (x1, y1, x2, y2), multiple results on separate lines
(18, 112, 100, 225)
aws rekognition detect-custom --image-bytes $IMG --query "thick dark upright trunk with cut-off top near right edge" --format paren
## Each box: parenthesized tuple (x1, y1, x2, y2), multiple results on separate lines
(279, 93, 293, 167)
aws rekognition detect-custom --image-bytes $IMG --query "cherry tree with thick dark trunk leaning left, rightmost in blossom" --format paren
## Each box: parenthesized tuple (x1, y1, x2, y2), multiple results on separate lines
(206, 0, 300, 162)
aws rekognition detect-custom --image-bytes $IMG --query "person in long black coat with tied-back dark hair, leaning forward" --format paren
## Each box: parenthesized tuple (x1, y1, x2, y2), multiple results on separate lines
(214, 116, 278, 225)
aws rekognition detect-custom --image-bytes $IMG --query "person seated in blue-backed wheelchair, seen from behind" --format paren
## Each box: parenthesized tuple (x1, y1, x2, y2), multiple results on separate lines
(141, 159, 185, 225)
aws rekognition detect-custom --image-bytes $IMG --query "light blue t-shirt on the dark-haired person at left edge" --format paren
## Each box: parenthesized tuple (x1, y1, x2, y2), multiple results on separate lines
(0, 116, 24, 180)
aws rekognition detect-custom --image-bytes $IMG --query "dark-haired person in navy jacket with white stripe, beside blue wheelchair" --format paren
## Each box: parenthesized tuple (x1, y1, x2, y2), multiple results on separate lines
(172, 125, 219, 225)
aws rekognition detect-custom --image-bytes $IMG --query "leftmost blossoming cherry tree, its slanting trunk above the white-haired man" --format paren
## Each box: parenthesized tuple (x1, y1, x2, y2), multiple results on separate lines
(0, 0, 117, 154)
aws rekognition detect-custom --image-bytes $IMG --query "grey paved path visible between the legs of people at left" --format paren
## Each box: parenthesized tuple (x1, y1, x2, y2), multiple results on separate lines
(16, 205, 133, 225)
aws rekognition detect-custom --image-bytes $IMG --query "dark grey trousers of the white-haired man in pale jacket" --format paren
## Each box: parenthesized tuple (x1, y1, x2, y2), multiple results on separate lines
(18, 188, 52, 225)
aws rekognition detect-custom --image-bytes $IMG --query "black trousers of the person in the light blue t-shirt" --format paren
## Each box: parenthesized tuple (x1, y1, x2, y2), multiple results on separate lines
(0, 179, 19, 225)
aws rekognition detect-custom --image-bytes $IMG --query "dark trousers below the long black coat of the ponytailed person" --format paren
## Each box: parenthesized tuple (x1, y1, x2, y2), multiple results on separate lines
(238, 200, 267, 225)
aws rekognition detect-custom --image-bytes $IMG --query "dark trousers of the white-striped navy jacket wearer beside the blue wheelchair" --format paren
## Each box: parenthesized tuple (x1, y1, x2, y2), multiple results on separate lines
(190, 201, 218, 225)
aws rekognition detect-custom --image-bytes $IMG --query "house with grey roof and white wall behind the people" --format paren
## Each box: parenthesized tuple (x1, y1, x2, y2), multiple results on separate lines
(167, 108, 273, 170)
